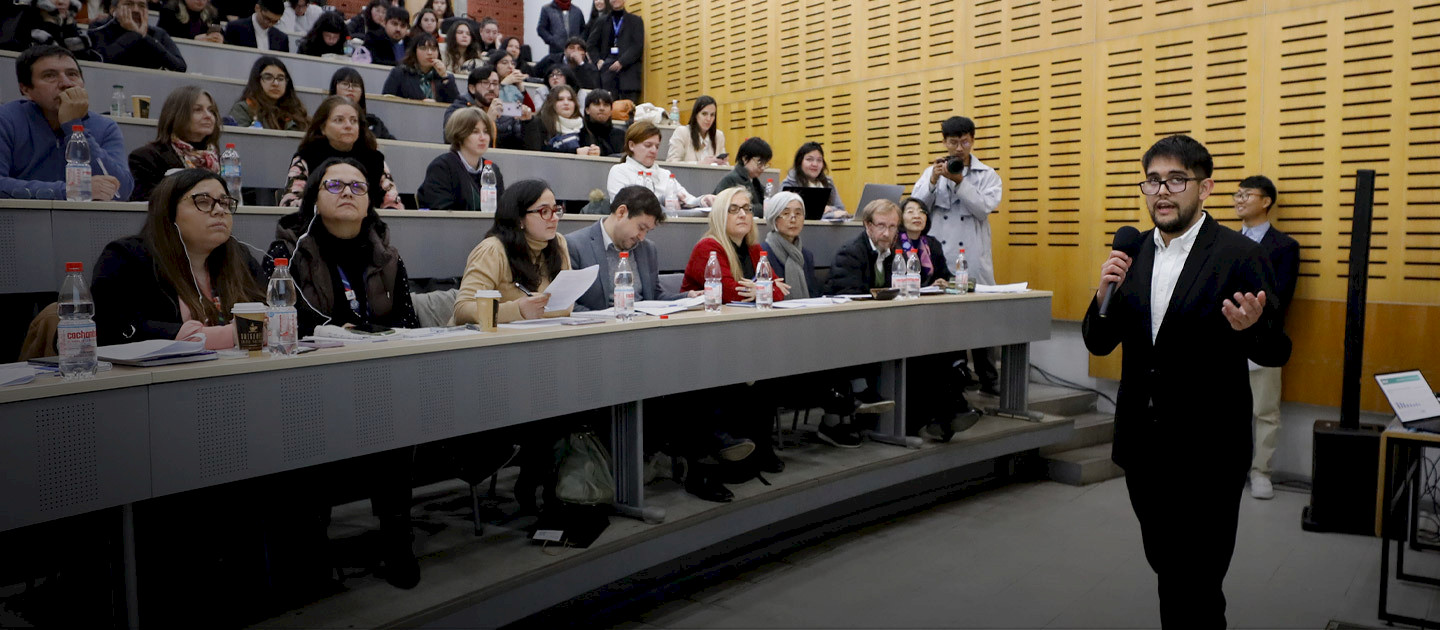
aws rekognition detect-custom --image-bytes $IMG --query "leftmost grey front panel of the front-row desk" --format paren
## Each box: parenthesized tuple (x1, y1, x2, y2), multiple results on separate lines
(0, 387, 153, 531)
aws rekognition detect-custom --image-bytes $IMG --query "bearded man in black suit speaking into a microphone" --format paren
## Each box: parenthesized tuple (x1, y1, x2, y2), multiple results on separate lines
(1081, 135, 1290, 629)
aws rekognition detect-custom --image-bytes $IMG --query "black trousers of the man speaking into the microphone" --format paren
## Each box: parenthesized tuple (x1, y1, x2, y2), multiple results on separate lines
(1125, 462, 1246, 629)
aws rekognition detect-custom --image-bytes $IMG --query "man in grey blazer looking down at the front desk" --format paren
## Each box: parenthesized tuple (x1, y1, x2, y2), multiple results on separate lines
(564, 186, 698, 311)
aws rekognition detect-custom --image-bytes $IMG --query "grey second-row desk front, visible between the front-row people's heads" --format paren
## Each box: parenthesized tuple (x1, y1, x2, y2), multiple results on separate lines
(0, 199, 861, 293)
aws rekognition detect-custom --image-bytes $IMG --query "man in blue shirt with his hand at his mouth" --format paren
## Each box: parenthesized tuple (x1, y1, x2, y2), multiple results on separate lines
(0, 46, 134, 201)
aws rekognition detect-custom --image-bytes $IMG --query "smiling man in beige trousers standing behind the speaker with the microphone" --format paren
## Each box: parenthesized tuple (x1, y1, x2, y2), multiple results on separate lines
(1234, 175, 1300, 499)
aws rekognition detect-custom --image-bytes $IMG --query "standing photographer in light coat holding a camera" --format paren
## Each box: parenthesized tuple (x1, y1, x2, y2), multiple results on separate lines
(910, 117, 1004, 396)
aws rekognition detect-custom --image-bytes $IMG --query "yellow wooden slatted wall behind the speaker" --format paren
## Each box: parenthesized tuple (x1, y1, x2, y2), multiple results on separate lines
(632, 0, 1440, 406)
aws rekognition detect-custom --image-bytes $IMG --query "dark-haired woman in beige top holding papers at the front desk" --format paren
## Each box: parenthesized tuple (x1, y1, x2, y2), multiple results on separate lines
(455, 180, 570, 324)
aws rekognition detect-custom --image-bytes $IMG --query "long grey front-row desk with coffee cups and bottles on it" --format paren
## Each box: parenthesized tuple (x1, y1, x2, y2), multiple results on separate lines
(0, 292, 1051, 531)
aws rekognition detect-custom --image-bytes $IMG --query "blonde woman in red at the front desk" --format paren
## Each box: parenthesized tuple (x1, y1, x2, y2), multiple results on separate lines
(680, 187, 791, 302)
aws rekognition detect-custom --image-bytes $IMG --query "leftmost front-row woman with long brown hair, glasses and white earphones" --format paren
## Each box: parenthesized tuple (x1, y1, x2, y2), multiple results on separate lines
(94, 168, 265, 350)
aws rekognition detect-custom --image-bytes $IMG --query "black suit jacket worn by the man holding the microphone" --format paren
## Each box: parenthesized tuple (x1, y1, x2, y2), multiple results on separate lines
(1081, 216, 1290, 476)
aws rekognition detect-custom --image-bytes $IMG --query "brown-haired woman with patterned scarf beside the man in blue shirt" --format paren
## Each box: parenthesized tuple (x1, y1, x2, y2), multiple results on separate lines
(130, 85, 226, 201)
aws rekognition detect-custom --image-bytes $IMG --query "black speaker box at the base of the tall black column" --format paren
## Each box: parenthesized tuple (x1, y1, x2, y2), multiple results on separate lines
(1300, 420, 1385, 537)
